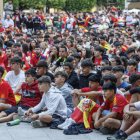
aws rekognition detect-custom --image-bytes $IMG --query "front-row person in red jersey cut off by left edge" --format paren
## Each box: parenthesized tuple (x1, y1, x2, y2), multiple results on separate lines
(0, 66, 16, 111)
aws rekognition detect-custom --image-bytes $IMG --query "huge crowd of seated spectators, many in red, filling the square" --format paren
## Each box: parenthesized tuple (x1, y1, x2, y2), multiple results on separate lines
(0, 0, 140, 140)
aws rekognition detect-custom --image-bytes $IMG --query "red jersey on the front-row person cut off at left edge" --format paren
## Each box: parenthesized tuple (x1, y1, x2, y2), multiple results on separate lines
(0, 79, 16, 106)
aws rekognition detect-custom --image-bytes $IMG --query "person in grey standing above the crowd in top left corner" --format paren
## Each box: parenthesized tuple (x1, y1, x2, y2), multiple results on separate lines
(4, 0, 13, 19)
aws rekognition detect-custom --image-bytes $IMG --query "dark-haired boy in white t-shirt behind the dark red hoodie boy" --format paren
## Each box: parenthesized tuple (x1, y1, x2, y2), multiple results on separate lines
(5, 56, 25, 103)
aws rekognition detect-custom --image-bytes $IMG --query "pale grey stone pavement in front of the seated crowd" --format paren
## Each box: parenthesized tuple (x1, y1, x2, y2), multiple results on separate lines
(0, 122, 140, 140)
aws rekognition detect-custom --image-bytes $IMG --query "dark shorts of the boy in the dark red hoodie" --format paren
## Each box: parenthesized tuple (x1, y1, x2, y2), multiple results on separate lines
(4, 105, 31, 116)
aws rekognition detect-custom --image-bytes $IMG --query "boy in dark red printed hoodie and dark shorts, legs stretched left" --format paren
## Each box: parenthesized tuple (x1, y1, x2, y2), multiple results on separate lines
(0, 69, 42, 123)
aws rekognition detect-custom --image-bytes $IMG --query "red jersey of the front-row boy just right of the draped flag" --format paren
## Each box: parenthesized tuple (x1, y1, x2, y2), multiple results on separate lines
(101, 94, 129, 120)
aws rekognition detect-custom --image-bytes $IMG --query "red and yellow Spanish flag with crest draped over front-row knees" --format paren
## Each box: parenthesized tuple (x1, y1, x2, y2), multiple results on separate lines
(71, 98, 100, 129)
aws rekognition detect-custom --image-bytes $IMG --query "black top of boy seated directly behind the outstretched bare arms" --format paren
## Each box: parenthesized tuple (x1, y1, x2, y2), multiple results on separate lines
(79, 73, 93, 89)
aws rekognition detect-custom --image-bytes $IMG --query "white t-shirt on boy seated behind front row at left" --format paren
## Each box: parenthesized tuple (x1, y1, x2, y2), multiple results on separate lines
(5, 70, 25, 94)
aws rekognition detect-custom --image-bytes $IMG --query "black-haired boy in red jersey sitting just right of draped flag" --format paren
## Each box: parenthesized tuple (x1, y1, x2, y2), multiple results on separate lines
(94, 82, 128, 134)
